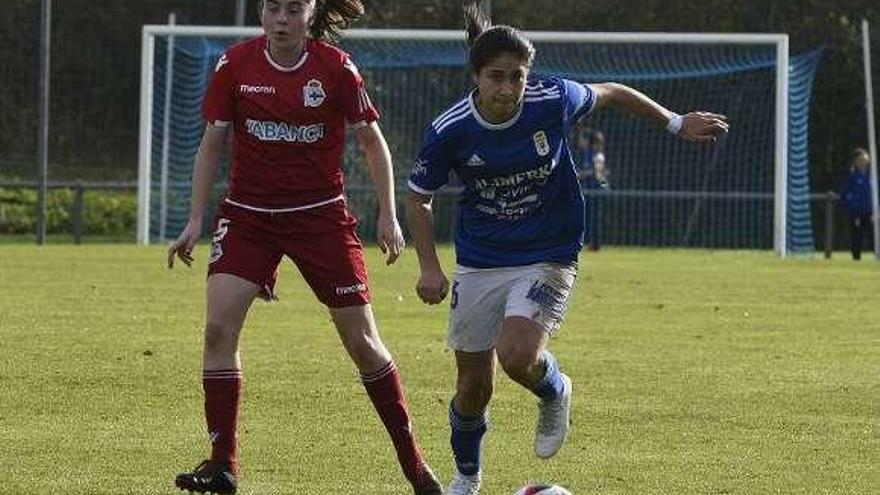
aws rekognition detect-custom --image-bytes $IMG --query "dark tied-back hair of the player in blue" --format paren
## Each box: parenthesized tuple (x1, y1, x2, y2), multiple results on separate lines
(464, 0, 535, 73)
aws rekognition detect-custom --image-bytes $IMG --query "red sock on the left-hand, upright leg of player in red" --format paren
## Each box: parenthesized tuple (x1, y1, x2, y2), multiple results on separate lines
(202, 369, 242, 474)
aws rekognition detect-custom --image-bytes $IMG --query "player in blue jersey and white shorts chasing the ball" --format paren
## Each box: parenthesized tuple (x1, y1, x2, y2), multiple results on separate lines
(407, 3, 728, 495)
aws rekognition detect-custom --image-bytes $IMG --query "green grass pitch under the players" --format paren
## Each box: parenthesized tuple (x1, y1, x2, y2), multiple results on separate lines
(0, 244, 880, 495)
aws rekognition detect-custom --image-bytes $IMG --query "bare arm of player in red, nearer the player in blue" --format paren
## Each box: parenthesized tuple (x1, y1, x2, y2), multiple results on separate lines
(355, 122, 406, 265)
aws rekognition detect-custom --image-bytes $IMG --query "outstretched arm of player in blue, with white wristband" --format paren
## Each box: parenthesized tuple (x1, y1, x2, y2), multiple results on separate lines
(590, 83, 730, 142)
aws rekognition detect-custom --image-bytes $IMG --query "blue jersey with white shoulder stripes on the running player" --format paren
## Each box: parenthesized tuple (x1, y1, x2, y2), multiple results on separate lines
(409, 78, 596, 268)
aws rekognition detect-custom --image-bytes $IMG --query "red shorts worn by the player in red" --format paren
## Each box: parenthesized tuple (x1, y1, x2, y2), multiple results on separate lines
(208, 200, 370, 307)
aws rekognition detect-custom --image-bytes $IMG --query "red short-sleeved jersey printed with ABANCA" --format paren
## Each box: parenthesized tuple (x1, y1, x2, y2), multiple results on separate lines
(202, 36, 379, 209)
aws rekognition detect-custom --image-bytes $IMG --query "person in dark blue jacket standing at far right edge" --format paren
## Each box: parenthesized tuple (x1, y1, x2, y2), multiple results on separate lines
(840, 148, 872, 260)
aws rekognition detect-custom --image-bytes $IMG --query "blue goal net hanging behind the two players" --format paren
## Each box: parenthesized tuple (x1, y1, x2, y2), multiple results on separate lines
(150, 37, 821, 253)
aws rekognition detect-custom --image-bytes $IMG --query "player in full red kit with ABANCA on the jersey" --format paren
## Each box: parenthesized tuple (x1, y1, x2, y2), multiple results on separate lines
(168, 0, 441, 494)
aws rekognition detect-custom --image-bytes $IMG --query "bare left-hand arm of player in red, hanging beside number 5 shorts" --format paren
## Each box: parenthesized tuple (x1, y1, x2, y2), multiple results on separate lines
(168, 124, 228, 268)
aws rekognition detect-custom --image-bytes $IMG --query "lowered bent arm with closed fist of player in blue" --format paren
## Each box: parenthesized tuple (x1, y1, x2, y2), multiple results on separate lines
(406, 191, 449, 304)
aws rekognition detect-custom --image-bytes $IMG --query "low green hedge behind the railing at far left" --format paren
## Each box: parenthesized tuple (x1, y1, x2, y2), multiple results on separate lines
(0, 188, 137, 236)
